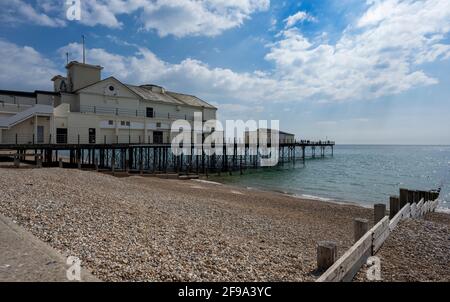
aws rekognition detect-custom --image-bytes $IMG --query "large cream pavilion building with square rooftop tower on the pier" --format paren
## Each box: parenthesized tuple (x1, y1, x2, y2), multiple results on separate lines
(0, 62, 217, 144)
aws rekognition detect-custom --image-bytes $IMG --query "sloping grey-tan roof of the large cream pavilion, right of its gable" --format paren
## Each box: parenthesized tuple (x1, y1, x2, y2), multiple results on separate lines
(126, 85, 217, 109)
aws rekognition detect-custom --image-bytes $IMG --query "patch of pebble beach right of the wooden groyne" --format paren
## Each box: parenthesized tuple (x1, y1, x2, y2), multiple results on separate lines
(355, 213, 450, 282)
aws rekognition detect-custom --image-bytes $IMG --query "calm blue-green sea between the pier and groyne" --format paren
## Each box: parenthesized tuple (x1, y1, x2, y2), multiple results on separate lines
(211, 145, 450, 213)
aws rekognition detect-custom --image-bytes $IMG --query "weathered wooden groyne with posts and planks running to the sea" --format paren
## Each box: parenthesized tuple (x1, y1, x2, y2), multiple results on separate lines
(316, 189, 440, 282)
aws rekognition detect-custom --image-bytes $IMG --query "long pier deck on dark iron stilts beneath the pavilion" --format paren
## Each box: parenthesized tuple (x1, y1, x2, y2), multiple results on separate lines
(0, 140, 335, 175)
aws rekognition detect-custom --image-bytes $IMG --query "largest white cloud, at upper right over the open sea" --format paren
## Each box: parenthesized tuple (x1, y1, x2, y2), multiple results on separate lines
(266, 0, 450, 101)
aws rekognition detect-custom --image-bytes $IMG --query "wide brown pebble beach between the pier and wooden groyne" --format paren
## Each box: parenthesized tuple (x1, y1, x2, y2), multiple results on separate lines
(0, 169, 448, 281)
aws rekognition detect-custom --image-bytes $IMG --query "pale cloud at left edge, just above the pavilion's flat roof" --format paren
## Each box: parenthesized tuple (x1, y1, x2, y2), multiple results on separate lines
(0, 39, 58, 91)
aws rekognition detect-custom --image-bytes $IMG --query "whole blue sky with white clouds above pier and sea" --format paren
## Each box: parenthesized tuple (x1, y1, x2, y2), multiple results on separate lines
(0, 0, 450, 144)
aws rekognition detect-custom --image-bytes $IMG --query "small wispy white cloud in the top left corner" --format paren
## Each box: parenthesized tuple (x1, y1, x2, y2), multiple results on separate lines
(0, 0, 66, 27)
